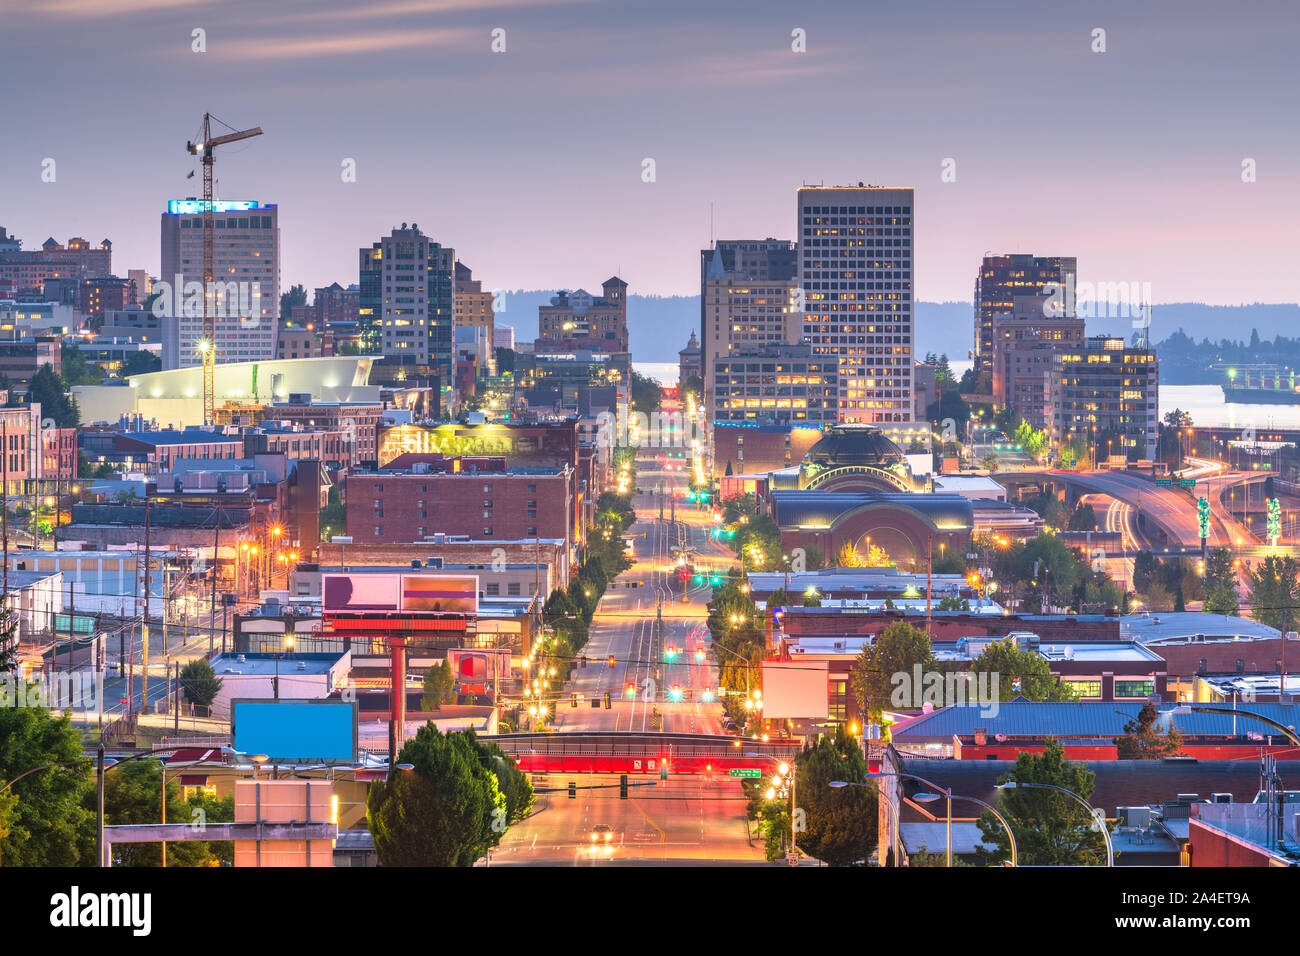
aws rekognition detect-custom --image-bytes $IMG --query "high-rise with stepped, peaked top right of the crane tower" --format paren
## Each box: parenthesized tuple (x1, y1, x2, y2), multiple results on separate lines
(358, 222, 456, 381)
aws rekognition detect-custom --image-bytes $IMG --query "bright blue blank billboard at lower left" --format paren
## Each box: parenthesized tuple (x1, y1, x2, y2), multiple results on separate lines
(230, 697, 358, 763)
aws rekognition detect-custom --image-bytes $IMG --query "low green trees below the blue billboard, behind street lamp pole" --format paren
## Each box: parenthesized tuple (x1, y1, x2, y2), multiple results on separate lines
(104, 760, 234, 866)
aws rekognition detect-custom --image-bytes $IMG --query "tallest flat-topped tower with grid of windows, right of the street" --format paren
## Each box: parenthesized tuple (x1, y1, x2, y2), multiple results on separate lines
(798, 185, 915, 424)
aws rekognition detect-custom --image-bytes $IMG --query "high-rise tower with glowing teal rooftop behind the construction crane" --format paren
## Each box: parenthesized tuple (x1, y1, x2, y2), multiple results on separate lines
(153, 198, 280, 368)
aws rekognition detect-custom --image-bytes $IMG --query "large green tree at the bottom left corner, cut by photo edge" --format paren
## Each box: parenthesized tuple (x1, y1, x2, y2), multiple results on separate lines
(0, 702, 95, 866)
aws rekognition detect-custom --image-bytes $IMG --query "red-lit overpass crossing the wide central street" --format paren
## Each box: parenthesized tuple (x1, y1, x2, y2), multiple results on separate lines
(491, 732, 801, 775)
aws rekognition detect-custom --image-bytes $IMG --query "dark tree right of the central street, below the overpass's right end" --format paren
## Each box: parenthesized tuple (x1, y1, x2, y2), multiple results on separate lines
(794, 727, 878, 866)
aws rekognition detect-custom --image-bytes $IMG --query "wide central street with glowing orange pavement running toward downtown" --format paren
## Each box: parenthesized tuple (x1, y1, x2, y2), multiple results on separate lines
(490, 458, 763, 866)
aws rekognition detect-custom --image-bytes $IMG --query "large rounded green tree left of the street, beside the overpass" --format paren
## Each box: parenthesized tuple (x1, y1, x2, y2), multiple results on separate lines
(365, 723, 510, 866)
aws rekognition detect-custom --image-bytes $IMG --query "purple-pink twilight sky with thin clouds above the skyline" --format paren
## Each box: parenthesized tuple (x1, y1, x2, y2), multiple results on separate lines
(0, 0, 1300, 303)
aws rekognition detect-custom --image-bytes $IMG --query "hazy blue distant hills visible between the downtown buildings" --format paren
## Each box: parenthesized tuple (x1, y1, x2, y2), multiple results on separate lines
(497, 290, 1300, 362)
